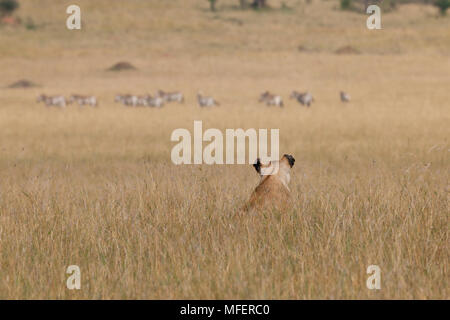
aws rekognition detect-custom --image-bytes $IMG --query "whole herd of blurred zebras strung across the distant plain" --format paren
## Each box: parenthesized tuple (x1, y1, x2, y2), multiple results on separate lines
(37, 90, 350, 108)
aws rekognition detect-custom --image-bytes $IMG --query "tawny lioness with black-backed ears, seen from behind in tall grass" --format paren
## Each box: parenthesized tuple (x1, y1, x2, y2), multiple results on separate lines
(244, 154, 295, 212)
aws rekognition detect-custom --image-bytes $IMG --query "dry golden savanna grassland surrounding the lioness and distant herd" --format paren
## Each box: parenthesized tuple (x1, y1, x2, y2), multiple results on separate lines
(0, 0, 450, 299)
